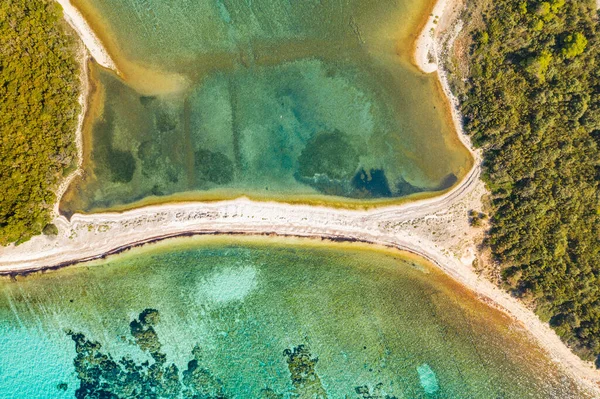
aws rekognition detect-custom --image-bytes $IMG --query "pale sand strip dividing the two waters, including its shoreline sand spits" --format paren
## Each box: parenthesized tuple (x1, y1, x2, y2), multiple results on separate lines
(0, 0, 600, 397)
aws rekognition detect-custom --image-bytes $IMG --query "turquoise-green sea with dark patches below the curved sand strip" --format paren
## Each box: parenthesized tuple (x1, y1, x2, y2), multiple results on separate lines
(0, 238, 585, 399)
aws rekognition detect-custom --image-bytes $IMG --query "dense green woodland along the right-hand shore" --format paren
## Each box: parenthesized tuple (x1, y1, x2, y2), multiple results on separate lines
(454, 0, 600, 360)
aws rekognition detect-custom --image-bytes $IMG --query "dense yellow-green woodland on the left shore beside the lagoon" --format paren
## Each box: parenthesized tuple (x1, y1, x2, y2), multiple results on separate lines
(0, 0, 80, 245)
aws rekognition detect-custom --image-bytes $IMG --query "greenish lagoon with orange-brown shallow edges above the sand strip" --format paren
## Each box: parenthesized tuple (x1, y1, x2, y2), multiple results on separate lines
(61, 0, 471, 213)
